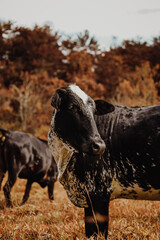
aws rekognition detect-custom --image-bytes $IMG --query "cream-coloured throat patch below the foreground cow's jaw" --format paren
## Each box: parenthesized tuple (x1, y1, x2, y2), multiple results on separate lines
(48, 110, 75, 179)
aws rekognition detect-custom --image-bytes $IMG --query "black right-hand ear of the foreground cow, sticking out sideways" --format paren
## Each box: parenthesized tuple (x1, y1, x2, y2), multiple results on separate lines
(95, 100, 115, 115)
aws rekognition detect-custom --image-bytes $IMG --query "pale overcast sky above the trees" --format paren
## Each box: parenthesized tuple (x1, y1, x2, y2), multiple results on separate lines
(0, 0, 160, 47)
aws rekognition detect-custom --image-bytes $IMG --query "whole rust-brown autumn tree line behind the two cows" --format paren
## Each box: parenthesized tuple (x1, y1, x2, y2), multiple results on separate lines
(0, 22, 160, 134)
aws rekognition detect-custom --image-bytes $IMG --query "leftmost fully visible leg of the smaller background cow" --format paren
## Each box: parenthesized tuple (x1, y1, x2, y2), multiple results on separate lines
(3, 171, 17, 207)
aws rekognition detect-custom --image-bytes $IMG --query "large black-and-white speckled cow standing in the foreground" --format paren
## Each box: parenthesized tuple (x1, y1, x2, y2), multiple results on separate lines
(48, 85, 160, 238)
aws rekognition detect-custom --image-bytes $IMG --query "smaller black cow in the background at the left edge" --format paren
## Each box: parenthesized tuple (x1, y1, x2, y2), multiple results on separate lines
(0, 128, 57, 207)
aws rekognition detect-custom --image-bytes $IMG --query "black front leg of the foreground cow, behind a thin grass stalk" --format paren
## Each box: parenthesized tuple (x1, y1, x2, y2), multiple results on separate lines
(85, 198, 109, 239)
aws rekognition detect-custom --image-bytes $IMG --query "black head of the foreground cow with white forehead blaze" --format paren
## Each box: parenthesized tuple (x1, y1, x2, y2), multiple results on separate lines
(49, 85, 114, 154)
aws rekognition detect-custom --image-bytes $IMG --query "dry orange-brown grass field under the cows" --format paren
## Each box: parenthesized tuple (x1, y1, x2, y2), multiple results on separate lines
(0, 179, 160, 240)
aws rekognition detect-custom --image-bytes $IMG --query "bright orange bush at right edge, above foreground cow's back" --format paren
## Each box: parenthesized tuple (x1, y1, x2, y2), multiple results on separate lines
(113, 62, 160, 106)
